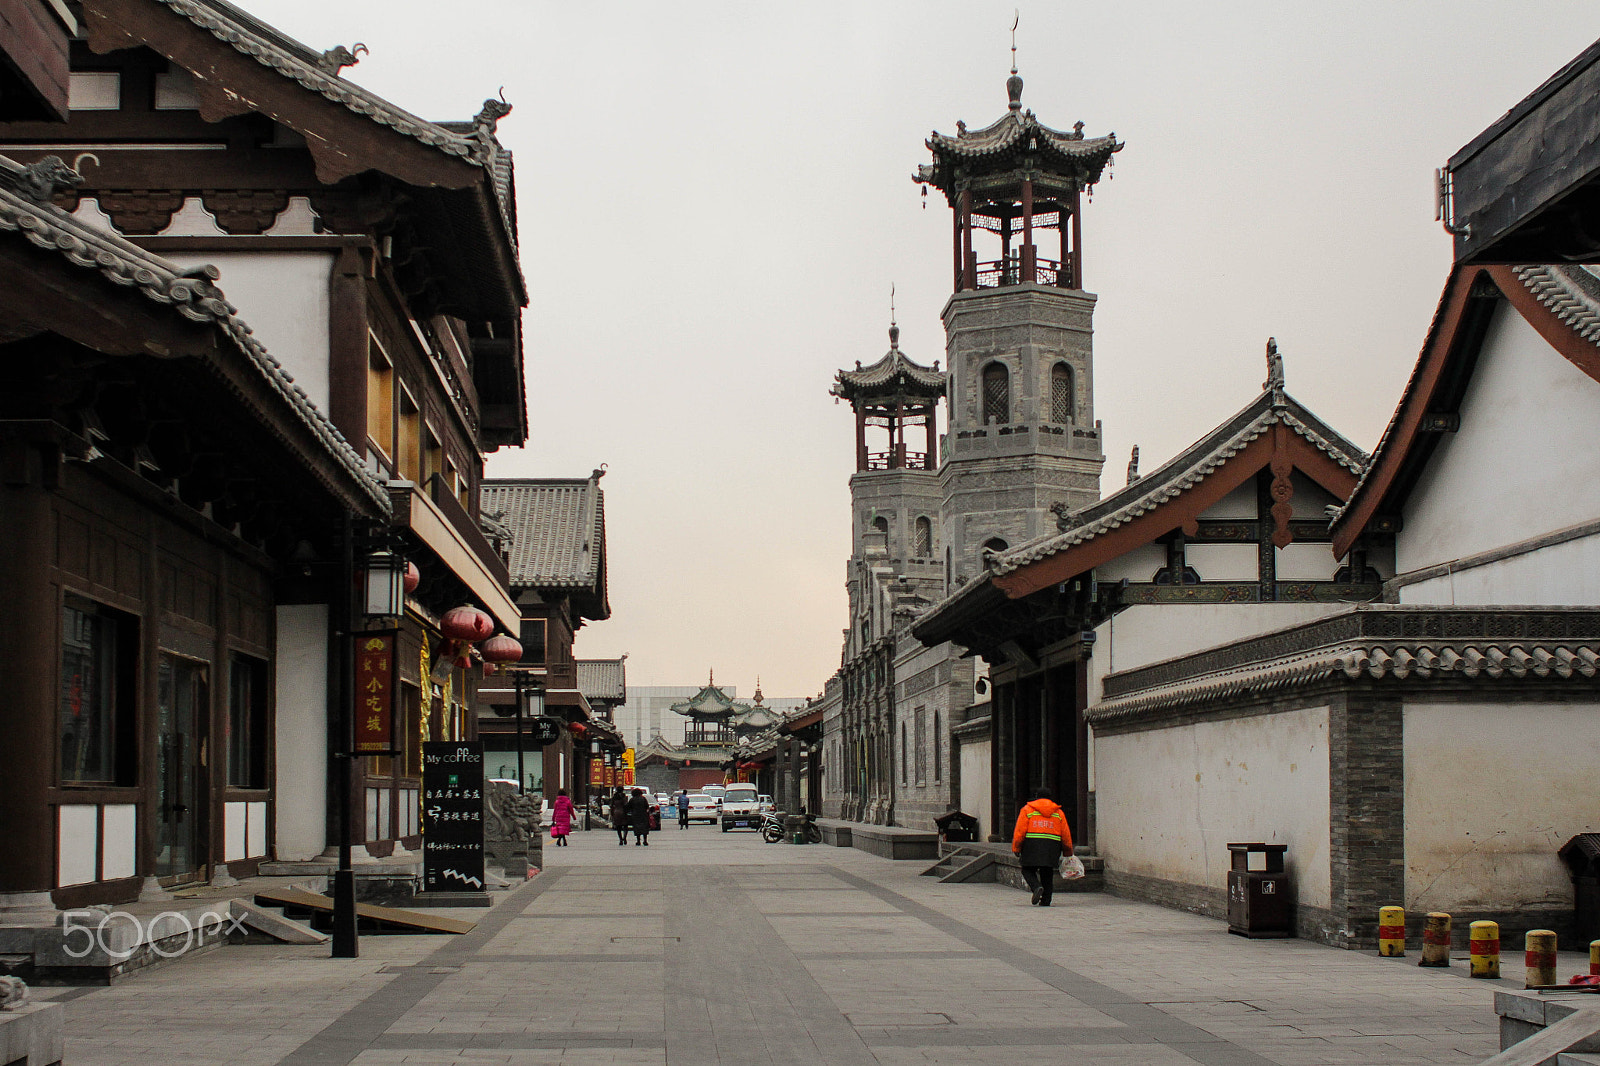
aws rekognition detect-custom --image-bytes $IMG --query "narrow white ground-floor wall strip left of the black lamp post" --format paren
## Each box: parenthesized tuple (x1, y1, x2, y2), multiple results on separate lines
(274, 603, 328, 863)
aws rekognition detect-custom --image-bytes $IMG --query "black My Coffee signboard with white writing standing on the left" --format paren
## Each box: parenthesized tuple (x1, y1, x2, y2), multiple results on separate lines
(422, 741, 483, 892)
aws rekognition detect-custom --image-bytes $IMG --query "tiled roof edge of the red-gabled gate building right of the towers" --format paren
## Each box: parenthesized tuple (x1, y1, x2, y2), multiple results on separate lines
(985, 389, 1366, 576)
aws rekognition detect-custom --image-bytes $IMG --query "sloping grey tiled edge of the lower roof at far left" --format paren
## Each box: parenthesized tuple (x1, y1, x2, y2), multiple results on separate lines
(0, 157, 389, 514)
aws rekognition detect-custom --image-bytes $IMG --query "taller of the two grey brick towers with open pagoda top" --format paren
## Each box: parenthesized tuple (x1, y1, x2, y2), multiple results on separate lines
(915, 61, 1122, 586)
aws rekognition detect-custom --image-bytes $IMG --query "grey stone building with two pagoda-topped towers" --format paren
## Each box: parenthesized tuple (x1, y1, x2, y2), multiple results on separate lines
(821, 70, 1122, 829)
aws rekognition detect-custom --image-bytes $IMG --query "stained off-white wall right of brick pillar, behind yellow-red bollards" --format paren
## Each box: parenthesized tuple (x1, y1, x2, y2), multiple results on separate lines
(1405, 703, 1600, 920)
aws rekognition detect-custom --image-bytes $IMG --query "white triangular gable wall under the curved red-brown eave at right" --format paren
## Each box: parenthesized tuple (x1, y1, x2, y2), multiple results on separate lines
(1395, 304, 1600, 573)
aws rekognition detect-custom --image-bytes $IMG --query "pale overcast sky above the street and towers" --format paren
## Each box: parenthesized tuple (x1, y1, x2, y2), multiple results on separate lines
(235, 0, 1600, 696)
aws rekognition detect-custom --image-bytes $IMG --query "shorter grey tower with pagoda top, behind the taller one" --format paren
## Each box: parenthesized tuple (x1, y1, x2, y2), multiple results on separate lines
(830, 316, 944, 646)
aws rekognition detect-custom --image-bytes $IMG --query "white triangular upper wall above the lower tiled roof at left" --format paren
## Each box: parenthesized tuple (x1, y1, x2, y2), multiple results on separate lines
(168, 250, 334, 415)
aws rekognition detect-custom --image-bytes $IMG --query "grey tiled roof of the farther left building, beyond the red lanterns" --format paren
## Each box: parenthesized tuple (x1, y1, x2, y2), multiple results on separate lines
(480, 477, 605, 599)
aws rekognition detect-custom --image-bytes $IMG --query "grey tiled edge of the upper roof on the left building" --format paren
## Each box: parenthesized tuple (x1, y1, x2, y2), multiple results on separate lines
(155, 0, 491, 165)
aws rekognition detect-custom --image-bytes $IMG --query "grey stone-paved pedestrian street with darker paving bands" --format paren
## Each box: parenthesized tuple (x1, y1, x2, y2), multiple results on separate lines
(37, 826, 1536, 1066)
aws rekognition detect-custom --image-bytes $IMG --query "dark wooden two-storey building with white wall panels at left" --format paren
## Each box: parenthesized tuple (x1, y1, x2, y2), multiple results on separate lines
(0, 0, 526, 900)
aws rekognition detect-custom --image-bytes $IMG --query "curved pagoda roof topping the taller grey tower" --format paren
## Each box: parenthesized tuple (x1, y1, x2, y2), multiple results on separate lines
(914, 75, 1123, 202)
